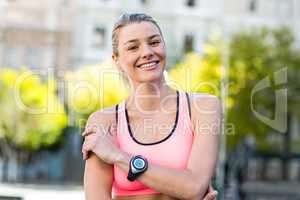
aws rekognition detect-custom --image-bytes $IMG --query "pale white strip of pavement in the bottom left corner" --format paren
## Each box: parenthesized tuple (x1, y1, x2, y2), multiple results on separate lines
(0, 183, 84, 200)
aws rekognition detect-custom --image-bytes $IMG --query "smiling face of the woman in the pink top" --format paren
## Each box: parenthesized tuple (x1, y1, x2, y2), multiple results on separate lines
(113, 21, 166, 84)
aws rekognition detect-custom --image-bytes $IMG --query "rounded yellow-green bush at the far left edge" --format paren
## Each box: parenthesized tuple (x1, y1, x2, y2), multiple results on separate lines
(0, 69, 67, 151)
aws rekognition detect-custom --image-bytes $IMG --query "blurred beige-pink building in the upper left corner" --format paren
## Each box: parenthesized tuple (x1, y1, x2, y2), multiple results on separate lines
(0, 0, 74, 72)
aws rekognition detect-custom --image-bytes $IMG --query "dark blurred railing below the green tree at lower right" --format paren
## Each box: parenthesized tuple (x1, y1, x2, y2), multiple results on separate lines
(224, 139, 300, 200)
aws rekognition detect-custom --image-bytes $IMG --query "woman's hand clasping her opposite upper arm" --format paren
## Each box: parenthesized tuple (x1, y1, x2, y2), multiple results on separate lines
(82, 123, 121, 164)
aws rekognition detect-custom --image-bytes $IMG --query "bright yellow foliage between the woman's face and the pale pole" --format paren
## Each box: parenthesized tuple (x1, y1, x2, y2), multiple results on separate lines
(167, 38, 222, 96)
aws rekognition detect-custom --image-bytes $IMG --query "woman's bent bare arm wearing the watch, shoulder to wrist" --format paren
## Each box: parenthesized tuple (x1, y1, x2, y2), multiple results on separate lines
(114, 96, 221, 199)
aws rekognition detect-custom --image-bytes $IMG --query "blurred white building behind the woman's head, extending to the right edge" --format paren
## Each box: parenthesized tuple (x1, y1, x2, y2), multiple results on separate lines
(72, 0, 300, 67)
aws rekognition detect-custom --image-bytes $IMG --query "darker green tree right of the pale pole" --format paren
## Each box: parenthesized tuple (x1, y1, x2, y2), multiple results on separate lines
(229, 27, 300, 178)
